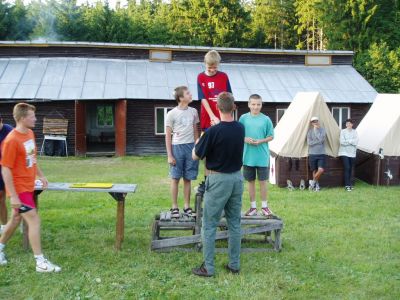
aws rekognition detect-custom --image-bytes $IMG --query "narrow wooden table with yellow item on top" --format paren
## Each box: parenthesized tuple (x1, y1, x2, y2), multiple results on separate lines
(23, 182, 137, 250)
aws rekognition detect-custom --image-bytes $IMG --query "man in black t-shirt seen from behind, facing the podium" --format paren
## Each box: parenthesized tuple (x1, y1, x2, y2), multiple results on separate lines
(192, 92, 244, 277)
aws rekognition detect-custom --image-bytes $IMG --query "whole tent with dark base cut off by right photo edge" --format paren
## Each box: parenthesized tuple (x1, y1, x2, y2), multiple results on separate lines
(356, 94, 400, 185)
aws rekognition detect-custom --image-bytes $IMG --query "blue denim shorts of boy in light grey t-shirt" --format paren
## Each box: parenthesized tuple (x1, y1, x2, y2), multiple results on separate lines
(169, 143, 199, 180)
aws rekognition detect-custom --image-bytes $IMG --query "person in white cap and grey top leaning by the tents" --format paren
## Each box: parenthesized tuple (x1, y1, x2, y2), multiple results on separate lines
(307, 117, 326, 192)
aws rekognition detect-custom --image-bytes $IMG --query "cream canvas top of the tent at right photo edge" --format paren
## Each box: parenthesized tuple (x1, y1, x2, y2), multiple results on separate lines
(357, 94, 400, 156)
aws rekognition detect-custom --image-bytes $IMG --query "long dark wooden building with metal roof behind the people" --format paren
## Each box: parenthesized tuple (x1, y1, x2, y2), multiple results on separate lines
(0, 42, 376, 155)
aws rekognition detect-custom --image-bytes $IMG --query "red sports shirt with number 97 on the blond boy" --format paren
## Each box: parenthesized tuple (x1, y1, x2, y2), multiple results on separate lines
(197, 71, 232, 129)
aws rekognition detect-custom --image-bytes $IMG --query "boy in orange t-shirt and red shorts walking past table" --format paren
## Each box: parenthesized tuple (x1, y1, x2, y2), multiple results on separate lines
(0, 103, 61, 272)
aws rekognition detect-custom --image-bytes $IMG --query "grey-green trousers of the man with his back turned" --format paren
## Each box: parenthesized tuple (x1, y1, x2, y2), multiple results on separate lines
(202, 171, 243, 274)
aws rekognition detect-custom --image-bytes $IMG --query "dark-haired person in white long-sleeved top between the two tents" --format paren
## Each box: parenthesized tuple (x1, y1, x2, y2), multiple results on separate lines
(338, 119, 358, 192)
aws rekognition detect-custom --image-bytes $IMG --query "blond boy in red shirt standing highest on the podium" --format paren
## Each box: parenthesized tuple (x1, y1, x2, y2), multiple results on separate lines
(197, 50, 232, 193)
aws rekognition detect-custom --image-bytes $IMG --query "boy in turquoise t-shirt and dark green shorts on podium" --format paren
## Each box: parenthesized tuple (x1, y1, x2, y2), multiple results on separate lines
(239, 94, 274, 217)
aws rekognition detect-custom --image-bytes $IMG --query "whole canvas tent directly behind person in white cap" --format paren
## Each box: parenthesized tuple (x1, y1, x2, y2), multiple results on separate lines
(270, 92, 343, 186)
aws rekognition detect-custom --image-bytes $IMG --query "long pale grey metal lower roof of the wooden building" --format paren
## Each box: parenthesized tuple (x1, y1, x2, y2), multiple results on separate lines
(0, 58, 377, 103)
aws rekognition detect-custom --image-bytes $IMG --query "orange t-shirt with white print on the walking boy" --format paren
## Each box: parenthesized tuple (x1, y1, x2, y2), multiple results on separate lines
(1, 129, 36, 194)
